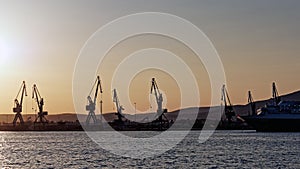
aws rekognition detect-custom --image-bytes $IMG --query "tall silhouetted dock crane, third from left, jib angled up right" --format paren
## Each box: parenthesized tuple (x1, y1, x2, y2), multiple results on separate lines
(86, 76, 103, 125)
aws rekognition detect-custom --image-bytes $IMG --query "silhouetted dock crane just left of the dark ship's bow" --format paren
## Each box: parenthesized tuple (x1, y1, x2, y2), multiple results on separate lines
(221, 85, 236, 123)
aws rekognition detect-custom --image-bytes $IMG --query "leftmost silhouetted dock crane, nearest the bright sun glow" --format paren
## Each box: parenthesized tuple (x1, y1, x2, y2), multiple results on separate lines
(13, 81, 27, 126)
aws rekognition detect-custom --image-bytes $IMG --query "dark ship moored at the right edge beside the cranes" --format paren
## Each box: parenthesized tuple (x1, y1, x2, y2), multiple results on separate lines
(243, 83, 300, 132)
